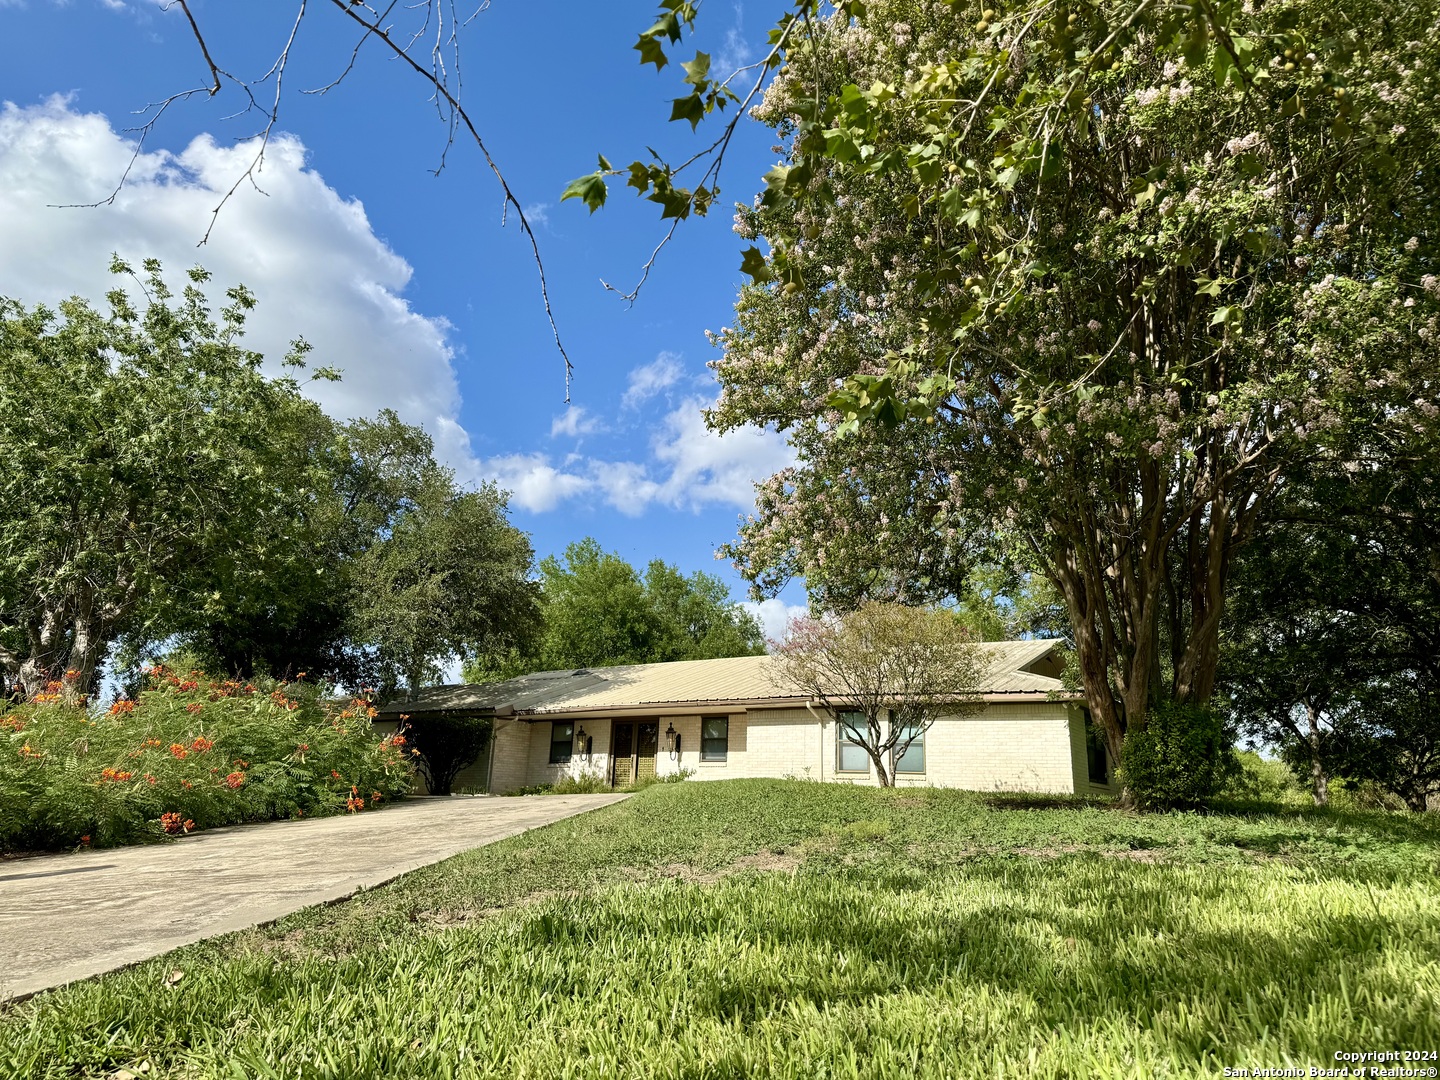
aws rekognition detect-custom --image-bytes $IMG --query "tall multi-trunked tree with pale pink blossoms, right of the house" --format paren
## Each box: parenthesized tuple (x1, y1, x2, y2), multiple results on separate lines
(711, 0, 1440, 783)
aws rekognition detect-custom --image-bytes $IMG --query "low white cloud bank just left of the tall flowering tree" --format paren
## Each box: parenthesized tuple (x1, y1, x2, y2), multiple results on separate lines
(484, 397, 795, 517)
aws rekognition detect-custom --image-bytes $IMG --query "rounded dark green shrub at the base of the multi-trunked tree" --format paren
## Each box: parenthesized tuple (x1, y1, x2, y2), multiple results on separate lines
(1120, 701, 1237, 809)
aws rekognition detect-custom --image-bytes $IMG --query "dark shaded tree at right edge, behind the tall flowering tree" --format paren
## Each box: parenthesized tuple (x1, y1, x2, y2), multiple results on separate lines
(1220, 452, 1440, 809)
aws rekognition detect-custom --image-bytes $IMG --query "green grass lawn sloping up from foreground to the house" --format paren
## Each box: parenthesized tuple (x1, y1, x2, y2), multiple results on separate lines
(0, 780, 1440, 1080)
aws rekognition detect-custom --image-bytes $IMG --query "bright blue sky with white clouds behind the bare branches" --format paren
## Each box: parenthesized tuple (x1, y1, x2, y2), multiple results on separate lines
(0, 0, 804, 642)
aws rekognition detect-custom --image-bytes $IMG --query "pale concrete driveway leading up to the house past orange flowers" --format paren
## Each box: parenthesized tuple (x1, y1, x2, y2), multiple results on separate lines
(0, 795, 625, 999)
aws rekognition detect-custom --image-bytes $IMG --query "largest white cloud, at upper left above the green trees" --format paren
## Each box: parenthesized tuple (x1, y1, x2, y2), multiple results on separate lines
(0, 98, 482, 480)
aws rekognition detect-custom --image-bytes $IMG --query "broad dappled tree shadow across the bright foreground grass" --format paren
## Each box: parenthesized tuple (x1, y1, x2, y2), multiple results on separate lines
(521, 855, 1440, 1060)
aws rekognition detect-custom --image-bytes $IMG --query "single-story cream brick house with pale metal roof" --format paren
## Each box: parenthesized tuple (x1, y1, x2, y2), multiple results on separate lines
(376, 641, 1117, 793)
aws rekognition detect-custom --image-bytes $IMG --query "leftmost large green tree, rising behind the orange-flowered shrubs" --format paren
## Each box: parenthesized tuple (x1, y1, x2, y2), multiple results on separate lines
(0, 261, 334, 694)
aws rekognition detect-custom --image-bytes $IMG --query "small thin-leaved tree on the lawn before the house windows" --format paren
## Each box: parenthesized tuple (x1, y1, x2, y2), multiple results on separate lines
(775, 600, 986, 788)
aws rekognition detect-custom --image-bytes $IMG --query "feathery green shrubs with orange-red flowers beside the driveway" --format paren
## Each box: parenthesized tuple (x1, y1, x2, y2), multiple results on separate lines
(0, 667, 413, 851)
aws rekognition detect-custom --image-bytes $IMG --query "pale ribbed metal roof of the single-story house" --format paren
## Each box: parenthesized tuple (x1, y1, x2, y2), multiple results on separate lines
(380, 641, 1063, 719)
